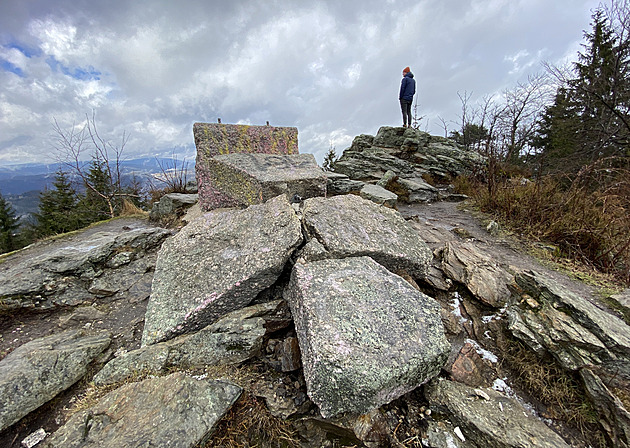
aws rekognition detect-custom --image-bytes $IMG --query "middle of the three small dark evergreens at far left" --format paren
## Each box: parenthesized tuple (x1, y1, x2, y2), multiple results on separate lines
(35, 171, 84, 237)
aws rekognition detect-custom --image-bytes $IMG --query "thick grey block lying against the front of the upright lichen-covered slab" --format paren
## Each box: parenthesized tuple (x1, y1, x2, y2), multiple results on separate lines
(207, 153, 327, 206)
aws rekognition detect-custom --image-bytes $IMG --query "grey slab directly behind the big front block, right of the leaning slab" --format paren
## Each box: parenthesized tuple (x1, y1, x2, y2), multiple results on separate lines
(302, 195, 433, 278)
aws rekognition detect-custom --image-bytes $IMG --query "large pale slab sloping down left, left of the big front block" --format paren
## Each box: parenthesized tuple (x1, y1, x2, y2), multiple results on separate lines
(142, 195, 302, 346)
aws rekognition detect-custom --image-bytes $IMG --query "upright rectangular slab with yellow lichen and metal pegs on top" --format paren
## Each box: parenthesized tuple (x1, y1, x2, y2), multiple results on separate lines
(193, 123, 299, 211)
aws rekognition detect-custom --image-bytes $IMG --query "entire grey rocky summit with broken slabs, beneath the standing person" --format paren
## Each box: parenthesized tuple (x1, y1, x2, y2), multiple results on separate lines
(0, 124, 630, 448)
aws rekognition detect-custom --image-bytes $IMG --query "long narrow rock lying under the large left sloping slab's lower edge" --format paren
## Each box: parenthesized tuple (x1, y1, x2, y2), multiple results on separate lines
(93, 301, 281, 386)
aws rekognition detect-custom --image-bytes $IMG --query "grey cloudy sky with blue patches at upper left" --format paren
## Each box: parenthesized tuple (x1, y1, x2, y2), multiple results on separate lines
(0, 0, 599, 165)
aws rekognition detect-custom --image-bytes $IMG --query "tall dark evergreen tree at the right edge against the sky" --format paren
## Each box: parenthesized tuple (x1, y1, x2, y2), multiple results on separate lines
(533, 8, 630, 173)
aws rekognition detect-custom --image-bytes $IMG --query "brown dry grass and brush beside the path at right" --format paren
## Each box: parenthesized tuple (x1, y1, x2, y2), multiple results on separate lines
(470, 160, 630, 284)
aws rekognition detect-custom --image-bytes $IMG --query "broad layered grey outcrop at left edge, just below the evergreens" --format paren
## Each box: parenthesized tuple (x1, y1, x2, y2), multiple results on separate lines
(0, 220, 170, 309)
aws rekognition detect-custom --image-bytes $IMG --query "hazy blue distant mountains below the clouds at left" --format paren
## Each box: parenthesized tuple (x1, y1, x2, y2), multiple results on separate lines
(0, 157, 195, 216)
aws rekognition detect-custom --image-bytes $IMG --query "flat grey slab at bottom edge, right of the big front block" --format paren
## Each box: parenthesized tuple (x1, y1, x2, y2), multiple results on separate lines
(425, 380, 569, 448)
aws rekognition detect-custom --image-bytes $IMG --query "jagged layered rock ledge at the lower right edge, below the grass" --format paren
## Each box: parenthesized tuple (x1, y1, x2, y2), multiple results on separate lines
(507, 271, 630, 446)
